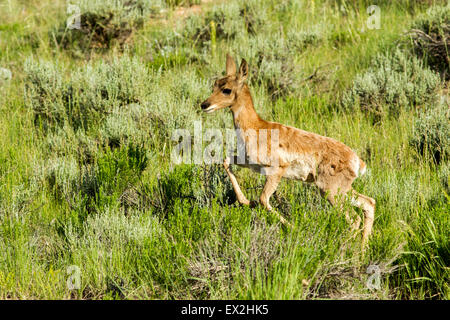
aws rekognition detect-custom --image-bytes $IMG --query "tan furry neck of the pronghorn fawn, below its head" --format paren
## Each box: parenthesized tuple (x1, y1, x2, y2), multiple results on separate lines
(231, 84, 263, 131)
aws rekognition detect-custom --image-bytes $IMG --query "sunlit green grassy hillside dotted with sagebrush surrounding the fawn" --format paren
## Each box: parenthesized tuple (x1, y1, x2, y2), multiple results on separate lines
(0, 0, 450, 299)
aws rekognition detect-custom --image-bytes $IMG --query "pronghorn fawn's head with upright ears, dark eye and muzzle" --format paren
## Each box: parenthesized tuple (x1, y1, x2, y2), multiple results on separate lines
(201, 54, 248, 113)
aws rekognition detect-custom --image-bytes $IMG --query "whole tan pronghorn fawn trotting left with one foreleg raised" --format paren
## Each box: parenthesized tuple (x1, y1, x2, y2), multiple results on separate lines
(201, 55, 375, 248)
